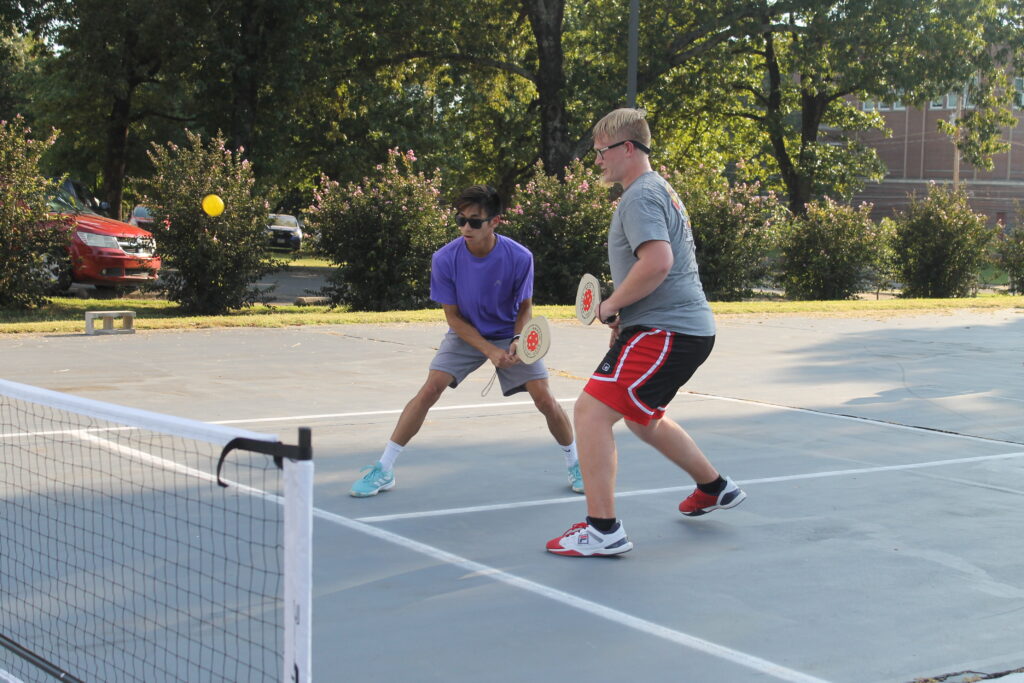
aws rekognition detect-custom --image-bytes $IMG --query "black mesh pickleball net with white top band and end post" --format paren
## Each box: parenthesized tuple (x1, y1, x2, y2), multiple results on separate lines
(0, 380, 312, 683)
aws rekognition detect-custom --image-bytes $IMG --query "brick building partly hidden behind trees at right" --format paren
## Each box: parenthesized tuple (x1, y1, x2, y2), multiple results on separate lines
(854, 84, 1024, 225)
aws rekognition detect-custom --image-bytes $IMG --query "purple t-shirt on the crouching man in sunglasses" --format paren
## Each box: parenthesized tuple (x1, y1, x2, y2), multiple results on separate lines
(430, 234, 534, 339)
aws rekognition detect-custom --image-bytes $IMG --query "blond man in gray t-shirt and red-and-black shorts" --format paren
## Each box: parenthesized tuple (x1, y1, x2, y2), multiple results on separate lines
(547, 109, 746, 557)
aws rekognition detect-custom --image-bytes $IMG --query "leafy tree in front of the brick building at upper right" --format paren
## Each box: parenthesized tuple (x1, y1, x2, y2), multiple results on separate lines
(667, 0, 1020, 214)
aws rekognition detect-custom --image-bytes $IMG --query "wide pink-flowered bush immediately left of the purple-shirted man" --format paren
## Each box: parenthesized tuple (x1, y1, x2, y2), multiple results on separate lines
(307, 150, 454, 310)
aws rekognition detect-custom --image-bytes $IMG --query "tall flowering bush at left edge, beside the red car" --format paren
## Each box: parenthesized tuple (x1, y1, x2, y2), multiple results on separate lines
(0, 117, 72, 309)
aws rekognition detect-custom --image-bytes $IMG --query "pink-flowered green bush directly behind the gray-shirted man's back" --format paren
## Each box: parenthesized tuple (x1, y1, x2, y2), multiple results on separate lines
(659, 165, 786, 301)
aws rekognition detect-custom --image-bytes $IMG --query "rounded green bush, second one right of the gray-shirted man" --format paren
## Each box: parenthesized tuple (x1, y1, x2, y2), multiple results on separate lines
(780, 199, 886, 301)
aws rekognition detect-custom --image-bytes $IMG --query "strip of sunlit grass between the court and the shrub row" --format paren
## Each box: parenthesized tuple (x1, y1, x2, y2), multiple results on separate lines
(0, 295, 1024, 334)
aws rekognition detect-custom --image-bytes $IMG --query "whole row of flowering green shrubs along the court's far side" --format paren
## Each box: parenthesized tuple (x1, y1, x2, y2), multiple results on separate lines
(0, 122, 1024, 313)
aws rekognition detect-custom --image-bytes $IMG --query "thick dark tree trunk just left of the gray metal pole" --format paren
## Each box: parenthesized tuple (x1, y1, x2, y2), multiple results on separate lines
(522, 0, 572, 178)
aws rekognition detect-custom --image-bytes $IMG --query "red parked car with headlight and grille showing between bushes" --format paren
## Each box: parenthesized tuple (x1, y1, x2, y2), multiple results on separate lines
(49, 185, 161, 289)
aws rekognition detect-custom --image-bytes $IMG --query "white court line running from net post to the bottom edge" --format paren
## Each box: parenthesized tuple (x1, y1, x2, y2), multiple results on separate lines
(313, 499, 827, 683)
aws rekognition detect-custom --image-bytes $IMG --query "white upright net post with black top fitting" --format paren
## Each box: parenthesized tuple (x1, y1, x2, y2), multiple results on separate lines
(282, 427, 313, 683)
